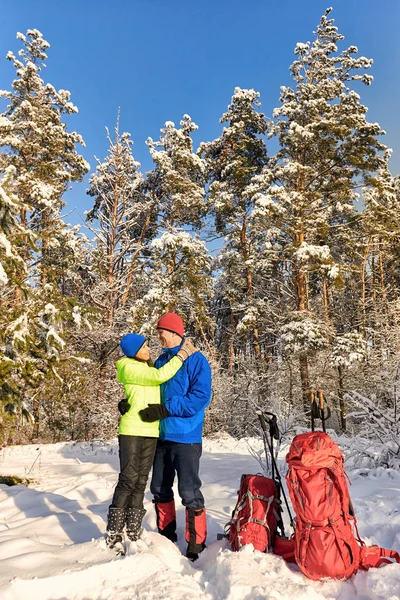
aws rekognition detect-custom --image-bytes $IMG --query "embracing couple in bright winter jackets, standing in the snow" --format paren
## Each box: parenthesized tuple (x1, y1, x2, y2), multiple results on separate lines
(106, 312, 211, 560)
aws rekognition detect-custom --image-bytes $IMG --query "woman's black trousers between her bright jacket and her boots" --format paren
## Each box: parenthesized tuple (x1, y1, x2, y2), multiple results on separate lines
(111, 435, 157, 508)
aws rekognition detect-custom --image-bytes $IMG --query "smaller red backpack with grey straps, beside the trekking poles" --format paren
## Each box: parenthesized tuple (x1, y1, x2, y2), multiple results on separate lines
(227, 475, 281, 552)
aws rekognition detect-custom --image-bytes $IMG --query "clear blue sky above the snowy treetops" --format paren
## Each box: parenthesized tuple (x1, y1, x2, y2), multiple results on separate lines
(0, 0, 400, 223)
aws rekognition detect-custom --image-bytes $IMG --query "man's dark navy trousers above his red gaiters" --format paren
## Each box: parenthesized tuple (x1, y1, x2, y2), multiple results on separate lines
(150, 440, 204, 508)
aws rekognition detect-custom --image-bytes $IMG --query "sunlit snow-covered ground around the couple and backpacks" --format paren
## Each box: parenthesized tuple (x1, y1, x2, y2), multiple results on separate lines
(0, 438, 400, 600)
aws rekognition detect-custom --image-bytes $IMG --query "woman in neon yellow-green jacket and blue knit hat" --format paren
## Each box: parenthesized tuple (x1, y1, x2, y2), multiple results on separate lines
(106, 333, 195, 552)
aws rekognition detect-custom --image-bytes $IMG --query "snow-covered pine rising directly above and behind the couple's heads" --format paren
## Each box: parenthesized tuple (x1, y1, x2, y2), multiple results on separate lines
(133, 115, 212, 342)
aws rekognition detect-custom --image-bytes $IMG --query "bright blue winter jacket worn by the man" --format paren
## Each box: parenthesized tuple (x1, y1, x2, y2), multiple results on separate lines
(154, 345, 211, 444)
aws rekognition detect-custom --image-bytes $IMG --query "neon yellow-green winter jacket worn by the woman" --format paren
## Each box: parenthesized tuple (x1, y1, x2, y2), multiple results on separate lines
(116, 356, 182, 437)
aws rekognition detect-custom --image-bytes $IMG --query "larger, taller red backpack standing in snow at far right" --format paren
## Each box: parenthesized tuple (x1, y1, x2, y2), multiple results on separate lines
(286, 431, 400, 580)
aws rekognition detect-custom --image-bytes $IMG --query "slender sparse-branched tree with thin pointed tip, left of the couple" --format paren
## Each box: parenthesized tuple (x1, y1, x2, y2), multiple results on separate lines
(87, 117, 156, 327)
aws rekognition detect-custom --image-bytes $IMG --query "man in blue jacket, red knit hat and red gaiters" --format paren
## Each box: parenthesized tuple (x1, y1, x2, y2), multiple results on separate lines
(140, 313, 211, 560)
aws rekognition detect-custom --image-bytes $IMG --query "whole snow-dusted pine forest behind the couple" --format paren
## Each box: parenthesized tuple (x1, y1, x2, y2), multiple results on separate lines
(0, 9, 400, 464)
